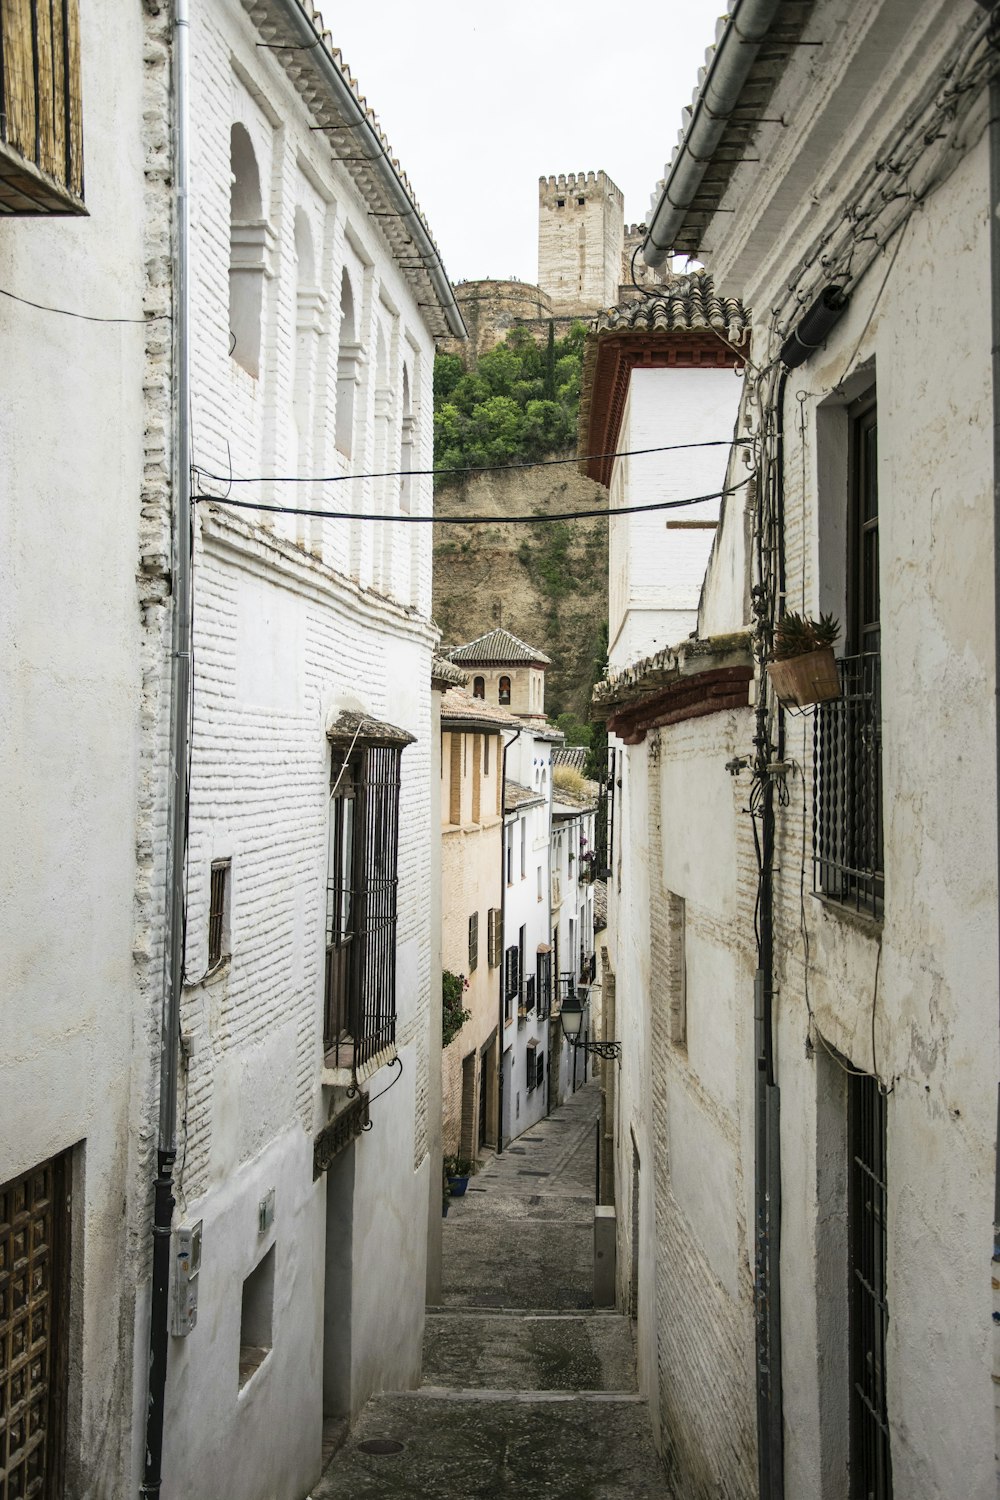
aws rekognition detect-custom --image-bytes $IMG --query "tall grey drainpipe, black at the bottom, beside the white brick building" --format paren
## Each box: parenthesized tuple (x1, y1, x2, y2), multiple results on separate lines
(139, 0, 192, 1500)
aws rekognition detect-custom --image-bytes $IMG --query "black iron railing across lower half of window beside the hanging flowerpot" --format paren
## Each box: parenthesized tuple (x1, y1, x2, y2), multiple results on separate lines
(813, 653, 885, 917)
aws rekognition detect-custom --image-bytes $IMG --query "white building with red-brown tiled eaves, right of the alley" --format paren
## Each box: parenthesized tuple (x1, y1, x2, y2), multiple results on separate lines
(582, 275, 754, 1494)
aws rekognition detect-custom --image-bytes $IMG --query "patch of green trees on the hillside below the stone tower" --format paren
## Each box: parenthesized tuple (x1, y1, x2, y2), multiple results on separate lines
(433, 323, 586, 485)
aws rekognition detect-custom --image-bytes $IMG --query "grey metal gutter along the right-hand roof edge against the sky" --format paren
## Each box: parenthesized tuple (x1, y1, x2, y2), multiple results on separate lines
(642, 0, 781, 269)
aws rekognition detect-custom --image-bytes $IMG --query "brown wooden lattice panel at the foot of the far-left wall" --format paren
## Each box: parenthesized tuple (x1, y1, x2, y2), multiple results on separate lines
(0, 1158, 64, 1500)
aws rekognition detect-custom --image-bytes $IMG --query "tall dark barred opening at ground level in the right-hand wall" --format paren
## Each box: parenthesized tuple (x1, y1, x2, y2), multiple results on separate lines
(847, 1074, 892, 1500)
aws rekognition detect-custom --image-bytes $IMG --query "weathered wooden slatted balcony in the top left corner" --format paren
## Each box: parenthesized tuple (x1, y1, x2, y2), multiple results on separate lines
(0, 0, 87, 215)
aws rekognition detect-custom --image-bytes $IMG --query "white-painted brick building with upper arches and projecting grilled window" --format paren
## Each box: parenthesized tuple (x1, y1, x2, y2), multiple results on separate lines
(154, 0, 462, 1500)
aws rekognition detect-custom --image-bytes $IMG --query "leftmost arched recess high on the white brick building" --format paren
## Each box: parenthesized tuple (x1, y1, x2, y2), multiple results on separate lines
(229, 125, 268, 380)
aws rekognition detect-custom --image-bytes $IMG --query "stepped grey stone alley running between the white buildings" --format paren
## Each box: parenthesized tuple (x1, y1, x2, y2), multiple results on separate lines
(312, 1083, 667, 1500)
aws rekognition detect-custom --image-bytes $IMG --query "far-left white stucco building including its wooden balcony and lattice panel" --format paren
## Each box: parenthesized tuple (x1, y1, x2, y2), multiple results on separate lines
(0, 0, 171, 1500)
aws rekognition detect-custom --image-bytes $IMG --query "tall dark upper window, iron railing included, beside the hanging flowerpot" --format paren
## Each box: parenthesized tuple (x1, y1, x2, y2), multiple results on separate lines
(813, 395, 885, 917)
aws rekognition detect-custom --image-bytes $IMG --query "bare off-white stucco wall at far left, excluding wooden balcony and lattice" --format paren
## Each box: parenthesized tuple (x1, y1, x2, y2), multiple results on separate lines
(0, 0, 156, 1500)
